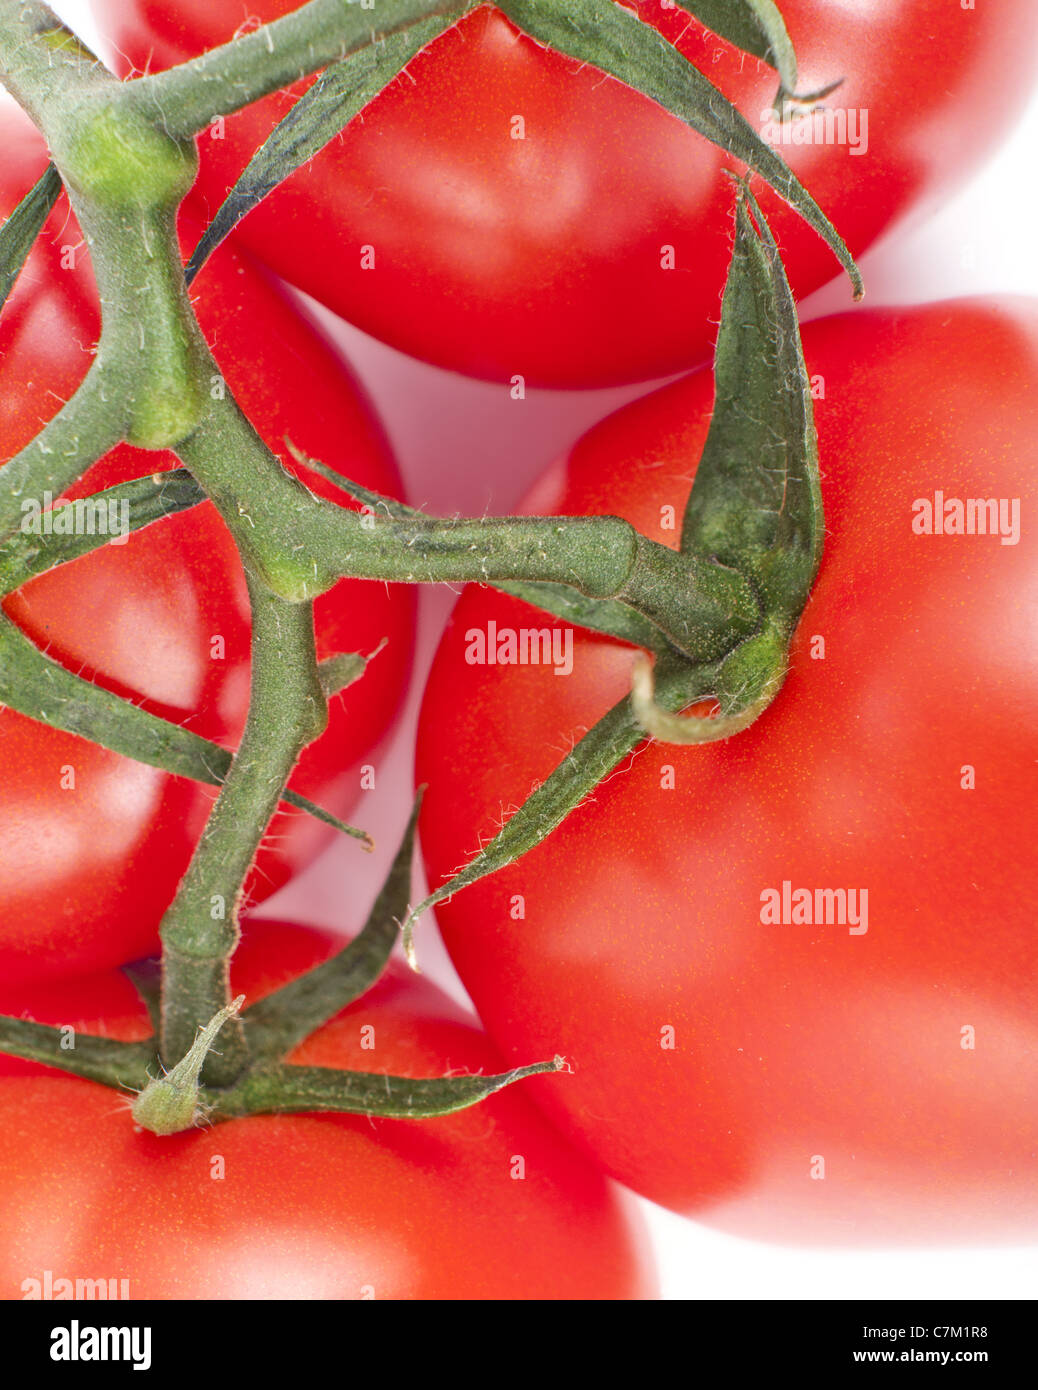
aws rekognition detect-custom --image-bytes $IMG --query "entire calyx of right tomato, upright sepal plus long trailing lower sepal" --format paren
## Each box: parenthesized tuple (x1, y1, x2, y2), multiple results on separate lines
(404, 179, 824, 963)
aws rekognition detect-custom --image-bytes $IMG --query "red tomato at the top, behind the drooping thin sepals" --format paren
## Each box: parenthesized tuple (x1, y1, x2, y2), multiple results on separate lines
(94, 0, 1038, 386)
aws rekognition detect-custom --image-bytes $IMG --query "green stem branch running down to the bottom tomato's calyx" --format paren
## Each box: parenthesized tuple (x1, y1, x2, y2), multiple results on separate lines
(160, 578, 328, 1086)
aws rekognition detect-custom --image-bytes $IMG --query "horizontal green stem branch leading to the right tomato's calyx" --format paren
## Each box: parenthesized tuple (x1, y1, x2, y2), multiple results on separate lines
(178, 396, 760, 659)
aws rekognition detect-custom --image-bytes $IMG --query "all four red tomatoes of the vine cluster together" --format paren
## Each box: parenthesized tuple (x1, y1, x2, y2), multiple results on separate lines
(0, 0, 1038, 1298)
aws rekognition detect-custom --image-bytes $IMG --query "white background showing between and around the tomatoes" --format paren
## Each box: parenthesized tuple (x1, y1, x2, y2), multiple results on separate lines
(56, 0, 1038, 1298)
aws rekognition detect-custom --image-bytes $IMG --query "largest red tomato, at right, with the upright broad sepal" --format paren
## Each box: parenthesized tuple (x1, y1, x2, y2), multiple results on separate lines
(418, 300, 1038, 1244)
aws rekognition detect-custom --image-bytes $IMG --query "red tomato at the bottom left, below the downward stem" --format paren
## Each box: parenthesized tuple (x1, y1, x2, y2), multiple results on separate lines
(0, 922, 656, 1300)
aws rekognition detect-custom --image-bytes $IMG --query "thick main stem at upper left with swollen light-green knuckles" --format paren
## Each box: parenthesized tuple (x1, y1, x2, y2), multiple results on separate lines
(0, 8, 206, 537)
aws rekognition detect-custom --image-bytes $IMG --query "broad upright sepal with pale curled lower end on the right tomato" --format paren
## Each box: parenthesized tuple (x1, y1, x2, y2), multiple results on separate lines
(616, 182, 824, 744)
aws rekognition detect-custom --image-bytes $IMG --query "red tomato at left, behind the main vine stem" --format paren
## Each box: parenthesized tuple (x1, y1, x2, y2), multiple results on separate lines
(0, 108, 413, 979)
